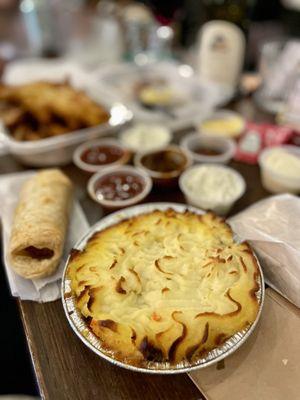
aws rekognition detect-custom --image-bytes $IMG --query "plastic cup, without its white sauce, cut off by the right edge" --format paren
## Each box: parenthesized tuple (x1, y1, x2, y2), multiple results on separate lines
(258, 145, 300, 194)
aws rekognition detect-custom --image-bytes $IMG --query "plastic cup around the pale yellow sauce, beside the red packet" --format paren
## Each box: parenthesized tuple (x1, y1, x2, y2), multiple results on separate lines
(195, 109, 246, 139)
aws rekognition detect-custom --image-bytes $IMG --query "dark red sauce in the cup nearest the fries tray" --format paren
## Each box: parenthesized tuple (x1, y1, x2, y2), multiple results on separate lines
(80, 144, 124, 165)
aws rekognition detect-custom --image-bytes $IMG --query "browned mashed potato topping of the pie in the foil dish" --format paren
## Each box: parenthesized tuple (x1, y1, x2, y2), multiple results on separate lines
(67, 210, 259, 366)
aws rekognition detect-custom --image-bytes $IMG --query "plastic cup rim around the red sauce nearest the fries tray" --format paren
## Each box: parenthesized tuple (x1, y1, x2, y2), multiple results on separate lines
(73, 139, 131, 173)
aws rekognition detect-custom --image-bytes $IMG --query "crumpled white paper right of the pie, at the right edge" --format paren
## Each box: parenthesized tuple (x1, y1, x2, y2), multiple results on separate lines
(229, 194, 300, 307)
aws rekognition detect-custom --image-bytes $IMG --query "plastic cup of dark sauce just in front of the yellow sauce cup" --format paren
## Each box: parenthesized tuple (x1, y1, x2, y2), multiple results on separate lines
(180, 133, 236, 164)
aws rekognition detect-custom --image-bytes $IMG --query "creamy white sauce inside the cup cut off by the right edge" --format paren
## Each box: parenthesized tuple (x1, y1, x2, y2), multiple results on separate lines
(265, 149, 300, 178)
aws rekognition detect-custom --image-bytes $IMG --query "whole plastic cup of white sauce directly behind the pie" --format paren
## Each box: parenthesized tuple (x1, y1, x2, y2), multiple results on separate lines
(179, 164, 246, 215)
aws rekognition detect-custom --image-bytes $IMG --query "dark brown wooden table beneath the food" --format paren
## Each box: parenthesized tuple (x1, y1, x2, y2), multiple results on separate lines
(0, 100, 270, 400)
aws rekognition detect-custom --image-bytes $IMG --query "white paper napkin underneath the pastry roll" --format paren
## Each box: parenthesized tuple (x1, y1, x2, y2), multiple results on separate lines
(0, 171, 89, 303)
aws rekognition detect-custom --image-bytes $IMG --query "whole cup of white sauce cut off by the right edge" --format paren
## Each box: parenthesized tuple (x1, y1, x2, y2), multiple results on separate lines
(258, 145, 300, 193)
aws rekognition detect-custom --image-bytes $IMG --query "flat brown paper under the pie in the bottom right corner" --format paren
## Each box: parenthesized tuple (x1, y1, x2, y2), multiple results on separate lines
(189, 288, 300, 400)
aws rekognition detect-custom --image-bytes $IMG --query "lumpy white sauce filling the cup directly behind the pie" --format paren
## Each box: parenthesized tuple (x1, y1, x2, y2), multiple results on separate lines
(186, 165, 241, 204)
